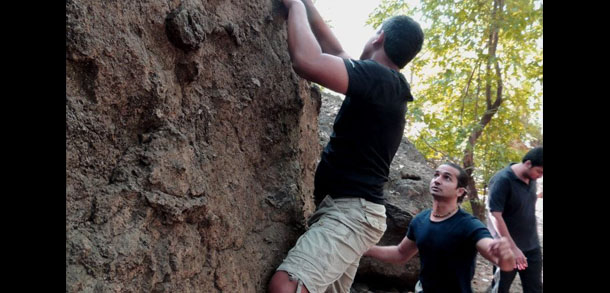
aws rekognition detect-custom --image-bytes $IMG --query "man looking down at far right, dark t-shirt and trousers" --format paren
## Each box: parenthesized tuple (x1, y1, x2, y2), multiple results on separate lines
(487, 147, 543, 293)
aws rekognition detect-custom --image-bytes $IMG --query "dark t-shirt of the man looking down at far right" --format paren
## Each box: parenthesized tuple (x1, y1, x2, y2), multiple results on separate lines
(489, 163, 540, 252)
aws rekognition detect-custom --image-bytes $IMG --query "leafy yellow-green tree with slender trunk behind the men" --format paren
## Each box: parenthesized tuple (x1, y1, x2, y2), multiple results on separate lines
(368, 0, 542, 220)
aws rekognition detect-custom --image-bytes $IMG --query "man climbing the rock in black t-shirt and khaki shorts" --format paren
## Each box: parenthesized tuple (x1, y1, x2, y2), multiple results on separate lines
(269, 0, 423, 292)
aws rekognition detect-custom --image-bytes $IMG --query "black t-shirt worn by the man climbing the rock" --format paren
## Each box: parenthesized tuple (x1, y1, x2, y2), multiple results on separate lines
(314, 59, 413, 204)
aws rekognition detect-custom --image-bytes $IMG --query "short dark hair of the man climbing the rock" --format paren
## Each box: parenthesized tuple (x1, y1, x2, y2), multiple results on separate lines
(381, 15, 424, 68)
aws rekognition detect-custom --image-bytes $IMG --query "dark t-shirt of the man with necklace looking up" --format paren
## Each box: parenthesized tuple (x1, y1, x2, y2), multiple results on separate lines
(407, 209, 492, 293)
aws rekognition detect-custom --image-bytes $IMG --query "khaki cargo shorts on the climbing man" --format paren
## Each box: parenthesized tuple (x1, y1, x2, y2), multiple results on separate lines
(277, 196, 386, 293)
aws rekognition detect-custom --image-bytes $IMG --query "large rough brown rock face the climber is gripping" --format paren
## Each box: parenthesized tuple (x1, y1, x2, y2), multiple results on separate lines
(66, 0, 320, 292)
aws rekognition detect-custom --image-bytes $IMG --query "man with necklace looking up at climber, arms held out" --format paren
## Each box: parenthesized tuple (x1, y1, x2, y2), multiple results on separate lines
(364, 163, 515, 293)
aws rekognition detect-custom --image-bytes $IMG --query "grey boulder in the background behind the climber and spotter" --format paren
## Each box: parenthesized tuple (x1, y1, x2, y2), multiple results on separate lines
(318, 93, 434, 292)
